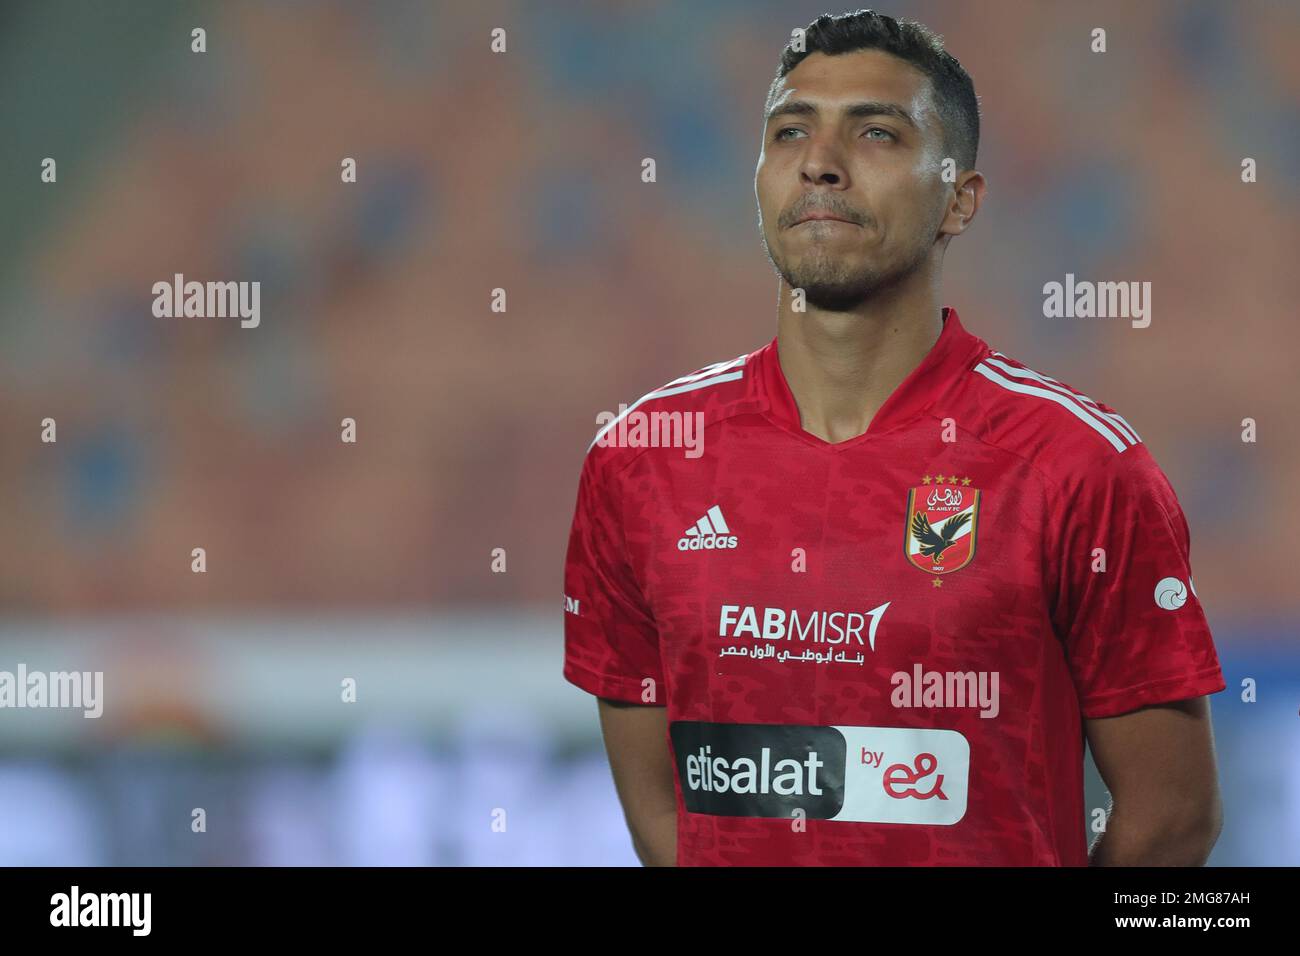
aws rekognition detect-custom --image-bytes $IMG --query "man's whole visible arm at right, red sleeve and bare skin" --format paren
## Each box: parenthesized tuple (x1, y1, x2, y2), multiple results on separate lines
(1053, 444, 1226, 866)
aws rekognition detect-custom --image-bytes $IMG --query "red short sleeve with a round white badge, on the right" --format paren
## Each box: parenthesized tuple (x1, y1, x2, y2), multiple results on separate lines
(1053, 444, 1226, 718)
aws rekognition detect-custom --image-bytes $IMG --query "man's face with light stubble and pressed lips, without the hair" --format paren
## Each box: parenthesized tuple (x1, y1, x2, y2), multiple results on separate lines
(754, 49, 950, 311)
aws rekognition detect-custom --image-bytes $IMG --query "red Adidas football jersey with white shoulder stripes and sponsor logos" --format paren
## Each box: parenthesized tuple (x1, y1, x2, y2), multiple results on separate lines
(564, 308, 1225, 866)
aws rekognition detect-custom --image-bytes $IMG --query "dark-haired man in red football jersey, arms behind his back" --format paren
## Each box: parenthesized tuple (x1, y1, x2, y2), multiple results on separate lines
(564, 12, 1225, 866)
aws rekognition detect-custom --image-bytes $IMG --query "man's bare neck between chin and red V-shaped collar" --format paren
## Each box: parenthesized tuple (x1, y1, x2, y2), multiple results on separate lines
(776, 281, 943, 444)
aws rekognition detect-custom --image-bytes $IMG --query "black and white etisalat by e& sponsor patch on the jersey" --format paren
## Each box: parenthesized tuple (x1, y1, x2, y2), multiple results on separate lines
(668, 721, 970, 826)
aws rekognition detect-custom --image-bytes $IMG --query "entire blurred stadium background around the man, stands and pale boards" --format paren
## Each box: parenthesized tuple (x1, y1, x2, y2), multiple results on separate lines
(0, 0, 1300, 865)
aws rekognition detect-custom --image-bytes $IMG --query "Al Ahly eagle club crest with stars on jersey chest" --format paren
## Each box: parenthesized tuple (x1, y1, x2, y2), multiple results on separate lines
(902, 475, 979, 575)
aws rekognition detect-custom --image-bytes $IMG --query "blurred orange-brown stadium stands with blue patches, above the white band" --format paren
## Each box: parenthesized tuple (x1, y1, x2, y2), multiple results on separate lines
(0, 0, 1300, 620)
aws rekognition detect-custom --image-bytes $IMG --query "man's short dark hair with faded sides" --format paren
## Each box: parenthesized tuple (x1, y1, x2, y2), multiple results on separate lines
(767, 10, 979, 169)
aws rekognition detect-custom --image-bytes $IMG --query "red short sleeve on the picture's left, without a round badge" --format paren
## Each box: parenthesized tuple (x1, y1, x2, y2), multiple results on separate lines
(564, 455, 666, 705)
